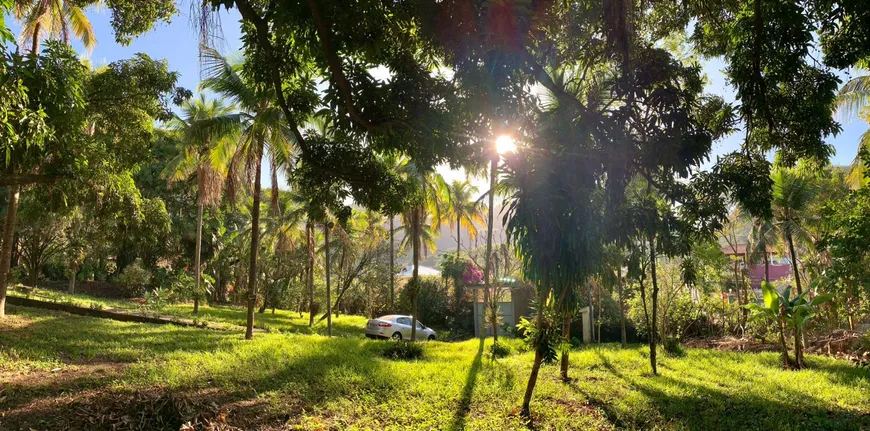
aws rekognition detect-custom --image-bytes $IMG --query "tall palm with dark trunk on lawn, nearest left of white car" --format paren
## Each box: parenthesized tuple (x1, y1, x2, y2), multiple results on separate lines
(200, 48, 295, 339)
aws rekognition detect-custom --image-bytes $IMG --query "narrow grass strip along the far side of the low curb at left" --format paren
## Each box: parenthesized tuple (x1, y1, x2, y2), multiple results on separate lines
(4, 289, 368, 337)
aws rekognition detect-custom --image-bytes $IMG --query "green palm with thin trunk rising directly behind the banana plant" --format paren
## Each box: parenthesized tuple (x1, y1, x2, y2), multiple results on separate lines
(771, 168, 817, 294)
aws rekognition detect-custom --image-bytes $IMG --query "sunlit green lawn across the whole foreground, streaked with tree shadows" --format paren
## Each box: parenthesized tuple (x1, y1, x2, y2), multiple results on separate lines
(0, 306, 870, 431)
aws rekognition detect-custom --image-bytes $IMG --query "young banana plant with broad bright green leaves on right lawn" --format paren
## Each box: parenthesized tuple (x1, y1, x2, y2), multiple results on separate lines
(745, 281, 834, 369)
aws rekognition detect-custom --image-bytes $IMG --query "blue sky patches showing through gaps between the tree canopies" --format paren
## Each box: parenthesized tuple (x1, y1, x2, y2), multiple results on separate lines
(7, 6, 868, 180)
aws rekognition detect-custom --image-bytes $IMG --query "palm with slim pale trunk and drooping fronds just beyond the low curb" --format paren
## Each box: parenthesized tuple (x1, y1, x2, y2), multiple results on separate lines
(163, 95, 238, 314)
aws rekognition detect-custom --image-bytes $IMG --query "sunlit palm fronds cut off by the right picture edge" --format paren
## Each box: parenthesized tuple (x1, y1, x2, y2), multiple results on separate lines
(837, 71, 870, 189)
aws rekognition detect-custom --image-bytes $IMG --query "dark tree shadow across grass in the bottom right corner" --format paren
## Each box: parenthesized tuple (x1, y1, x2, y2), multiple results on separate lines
(572, 354, 870, 431)
